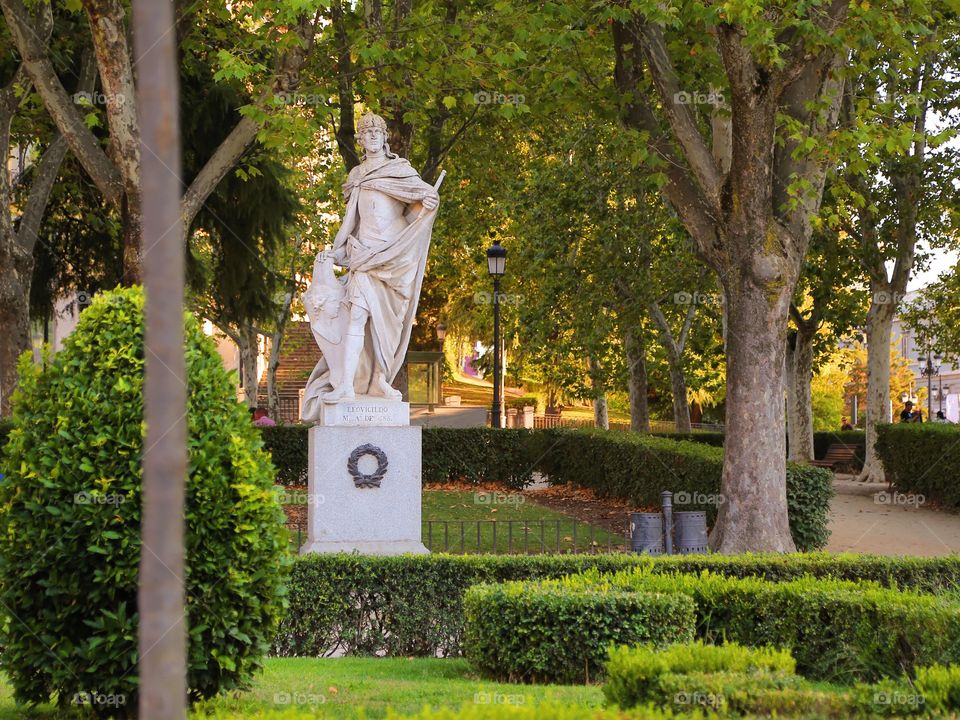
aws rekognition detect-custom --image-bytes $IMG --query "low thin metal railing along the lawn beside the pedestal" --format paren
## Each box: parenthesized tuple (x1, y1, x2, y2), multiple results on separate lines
(286, 518, 630, 555)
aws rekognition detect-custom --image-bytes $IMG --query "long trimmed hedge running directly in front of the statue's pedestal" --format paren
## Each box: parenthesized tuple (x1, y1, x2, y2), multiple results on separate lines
(272, 553, 960, 657)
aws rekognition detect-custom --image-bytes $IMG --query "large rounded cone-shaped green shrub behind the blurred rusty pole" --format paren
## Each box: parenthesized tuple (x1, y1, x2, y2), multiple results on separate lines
(0, 288, 285, 715)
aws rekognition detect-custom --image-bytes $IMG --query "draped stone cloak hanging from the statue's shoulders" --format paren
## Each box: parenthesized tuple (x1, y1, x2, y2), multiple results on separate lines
(301, 158, 437, 420)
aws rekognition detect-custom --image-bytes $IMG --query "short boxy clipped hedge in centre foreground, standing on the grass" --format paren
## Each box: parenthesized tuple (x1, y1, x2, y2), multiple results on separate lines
(463, 582, 696, 684)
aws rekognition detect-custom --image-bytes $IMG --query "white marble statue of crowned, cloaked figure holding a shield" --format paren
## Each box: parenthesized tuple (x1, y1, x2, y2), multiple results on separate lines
(301, 113, 443, 420)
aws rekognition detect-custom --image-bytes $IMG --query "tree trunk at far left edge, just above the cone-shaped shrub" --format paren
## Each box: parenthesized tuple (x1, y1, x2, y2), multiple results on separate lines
(0, 237, 33, 417)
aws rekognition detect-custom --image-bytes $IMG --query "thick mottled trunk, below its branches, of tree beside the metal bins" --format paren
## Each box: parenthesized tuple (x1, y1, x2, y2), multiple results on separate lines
(710, 273, 796, 554)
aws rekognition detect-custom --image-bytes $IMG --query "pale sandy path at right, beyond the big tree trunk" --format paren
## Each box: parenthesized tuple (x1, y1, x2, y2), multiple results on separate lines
(827, 475, 960, 555)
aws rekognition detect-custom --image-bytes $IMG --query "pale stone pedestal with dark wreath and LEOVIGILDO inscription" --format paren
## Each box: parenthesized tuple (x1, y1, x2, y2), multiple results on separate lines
(300, 398, 428, 555)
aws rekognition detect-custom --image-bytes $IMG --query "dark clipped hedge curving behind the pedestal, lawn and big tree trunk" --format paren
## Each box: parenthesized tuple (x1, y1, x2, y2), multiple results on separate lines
(263, 425, 833, 551)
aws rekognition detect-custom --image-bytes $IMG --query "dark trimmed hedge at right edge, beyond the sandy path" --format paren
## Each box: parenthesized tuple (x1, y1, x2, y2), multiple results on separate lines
(876, 423, 960, 510)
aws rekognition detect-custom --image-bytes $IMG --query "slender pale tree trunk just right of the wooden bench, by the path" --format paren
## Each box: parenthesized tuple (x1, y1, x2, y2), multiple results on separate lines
(857, 292, 896, 482)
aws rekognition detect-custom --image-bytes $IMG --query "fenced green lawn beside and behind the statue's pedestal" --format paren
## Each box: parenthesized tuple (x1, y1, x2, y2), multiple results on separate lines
(289, 490, 627, 555)
